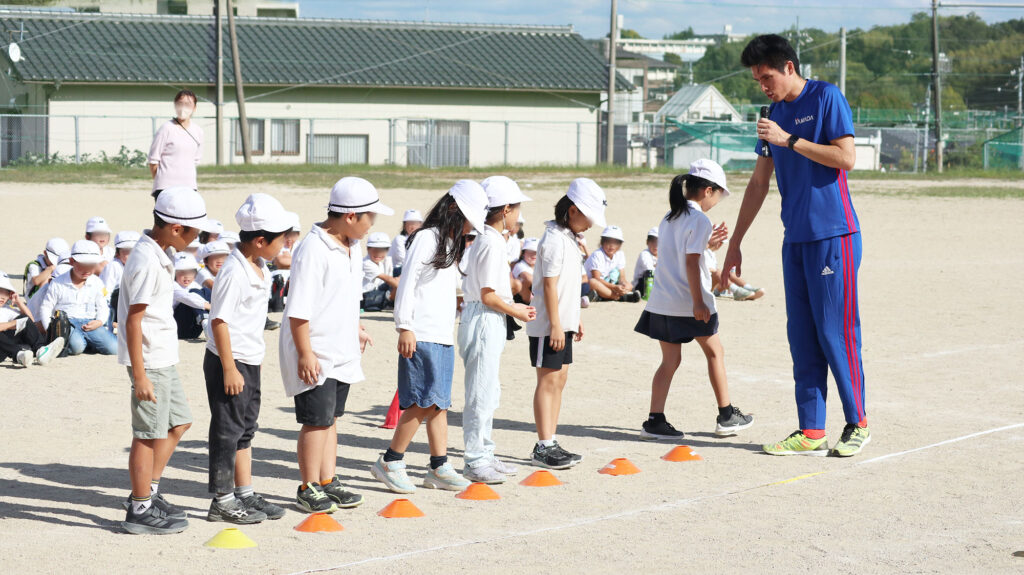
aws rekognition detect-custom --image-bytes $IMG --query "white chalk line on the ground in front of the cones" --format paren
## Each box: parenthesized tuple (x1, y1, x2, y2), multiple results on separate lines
(282, 423, 1024, 575)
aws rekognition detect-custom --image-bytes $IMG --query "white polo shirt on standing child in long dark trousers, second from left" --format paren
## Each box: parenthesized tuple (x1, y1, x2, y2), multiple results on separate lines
(206, 249, 270, 365)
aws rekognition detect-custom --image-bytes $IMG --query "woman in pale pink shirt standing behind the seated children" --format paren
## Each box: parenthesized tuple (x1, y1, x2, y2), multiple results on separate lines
(150, 90, 203, 198)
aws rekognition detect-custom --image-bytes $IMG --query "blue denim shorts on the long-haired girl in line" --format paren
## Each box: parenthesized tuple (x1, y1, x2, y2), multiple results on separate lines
(398, 342, 455, 409)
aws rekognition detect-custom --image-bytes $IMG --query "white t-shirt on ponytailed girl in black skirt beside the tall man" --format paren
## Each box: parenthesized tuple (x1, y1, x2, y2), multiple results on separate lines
(646, 201, 717, 317)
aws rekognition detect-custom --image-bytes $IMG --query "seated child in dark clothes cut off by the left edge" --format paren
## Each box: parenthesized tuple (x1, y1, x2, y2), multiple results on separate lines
(0, 271, 65, 367)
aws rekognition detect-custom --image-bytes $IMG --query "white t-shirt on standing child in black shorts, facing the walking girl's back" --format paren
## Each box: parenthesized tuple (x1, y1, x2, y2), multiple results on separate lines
(526, 222, 583, 338)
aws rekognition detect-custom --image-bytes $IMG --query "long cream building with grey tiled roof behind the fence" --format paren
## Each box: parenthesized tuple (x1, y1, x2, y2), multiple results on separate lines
(0, 10, 633, 166)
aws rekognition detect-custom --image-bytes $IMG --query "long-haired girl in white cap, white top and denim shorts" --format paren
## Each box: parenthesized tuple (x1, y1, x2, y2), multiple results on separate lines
(371, 180, 487, 493)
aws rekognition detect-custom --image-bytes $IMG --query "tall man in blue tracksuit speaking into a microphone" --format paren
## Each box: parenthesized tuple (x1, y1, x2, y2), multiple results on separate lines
(722, 35, 870, 456)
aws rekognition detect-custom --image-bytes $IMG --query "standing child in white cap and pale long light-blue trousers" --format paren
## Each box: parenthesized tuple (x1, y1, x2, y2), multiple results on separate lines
(459, 176, 537, 483)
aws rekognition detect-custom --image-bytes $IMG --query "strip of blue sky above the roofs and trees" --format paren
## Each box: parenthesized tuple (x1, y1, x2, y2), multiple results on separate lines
(299, 0, 1024, 38)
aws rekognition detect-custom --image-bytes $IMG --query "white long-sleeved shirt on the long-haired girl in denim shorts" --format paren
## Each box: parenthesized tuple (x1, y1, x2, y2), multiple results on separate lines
(394, 228, 456, 346)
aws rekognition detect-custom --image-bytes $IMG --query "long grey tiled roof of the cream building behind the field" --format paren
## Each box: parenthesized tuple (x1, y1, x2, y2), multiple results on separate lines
(0, 10, 632, 92)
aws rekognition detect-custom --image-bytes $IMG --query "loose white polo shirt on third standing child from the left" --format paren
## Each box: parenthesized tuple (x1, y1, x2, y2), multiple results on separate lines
(280, 225, 364, 397)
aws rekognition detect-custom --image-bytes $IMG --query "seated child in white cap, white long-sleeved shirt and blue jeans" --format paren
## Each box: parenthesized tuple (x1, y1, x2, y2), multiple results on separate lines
(39, 239, 118, 355)
